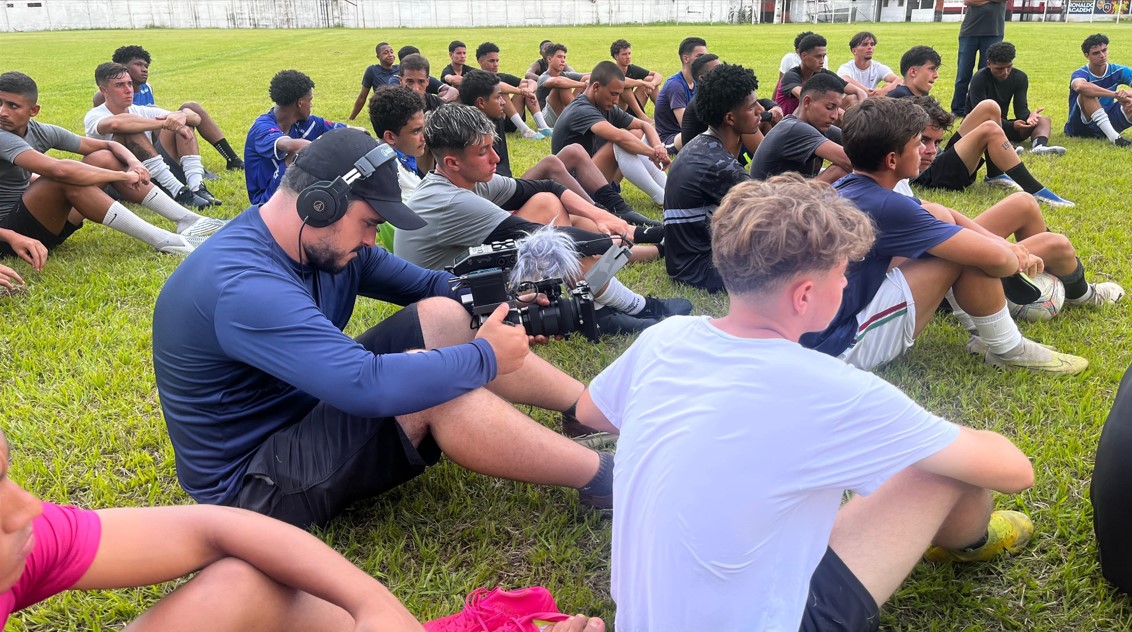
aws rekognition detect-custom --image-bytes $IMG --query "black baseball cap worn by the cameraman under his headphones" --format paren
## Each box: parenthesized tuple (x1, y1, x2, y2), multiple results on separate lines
(294, 127, 428, 230)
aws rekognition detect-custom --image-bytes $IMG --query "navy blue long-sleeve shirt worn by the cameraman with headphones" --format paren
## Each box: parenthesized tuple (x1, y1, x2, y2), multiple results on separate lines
(153, 206, 497, 503)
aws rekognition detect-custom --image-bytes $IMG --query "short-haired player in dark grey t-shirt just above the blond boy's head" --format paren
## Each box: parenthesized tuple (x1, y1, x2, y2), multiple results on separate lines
(751, 72, 852, 183)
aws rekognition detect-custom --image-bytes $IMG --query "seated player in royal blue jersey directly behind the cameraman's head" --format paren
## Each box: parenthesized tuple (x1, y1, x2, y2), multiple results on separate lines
(243, 70, 345, 204)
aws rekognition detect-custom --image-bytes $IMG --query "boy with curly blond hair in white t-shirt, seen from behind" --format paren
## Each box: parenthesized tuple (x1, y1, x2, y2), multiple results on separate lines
(577, 174, 1034, 632)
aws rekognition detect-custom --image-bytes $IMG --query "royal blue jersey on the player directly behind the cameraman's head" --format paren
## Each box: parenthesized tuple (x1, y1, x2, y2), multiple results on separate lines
(243, 110, 346, 204)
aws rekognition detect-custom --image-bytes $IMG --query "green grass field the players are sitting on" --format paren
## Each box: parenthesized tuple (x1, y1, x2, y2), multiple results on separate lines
(0, 24, 1132, 631)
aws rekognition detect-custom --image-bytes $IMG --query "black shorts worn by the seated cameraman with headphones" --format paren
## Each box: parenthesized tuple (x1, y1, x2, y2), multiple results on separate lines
(228, 305, 440, 528)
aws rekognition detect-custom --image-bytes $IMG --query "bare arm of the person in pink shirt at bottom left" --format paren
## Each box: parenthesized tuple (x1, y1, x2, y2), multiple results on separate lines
(74, 505, 421, 631)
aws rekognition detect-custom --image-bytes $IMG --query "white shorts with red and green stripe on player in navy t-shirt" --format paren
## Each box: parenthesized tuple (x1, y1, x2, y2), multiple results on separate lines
(839, 267, 916, 370)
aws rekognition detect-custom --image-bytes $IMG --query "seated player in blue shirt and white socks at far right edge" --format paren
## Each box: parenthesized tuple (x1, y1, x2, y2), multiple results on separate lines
(1065, 33, 1132, 147)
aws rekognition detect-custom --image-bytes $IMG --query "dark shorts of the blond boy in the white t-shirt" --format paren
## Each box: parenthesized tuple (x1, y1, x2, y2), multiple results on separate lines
(799, 547, 881, 632)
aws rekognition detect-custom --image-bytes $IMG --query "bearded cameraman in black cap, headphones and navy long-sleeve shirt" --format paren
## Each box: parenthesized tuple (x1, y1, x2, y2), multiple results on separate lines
(153, 129, 612, 527)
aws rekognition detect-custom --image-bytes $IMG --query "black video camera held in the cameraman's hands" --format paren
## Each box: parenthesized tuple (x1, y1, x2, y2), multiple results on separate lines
(447, 239, 600, 342)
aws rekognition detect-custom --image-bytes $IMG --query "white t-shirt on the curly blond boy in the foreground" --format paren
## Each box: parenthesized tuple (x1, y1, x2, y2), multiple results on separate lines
(590, 316, 959, 632)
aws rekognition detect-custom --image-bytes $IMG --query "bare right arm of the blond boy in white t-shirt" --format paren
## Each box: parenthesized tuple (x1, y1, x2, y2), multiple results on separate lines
(910, 425, 1034, 494)
